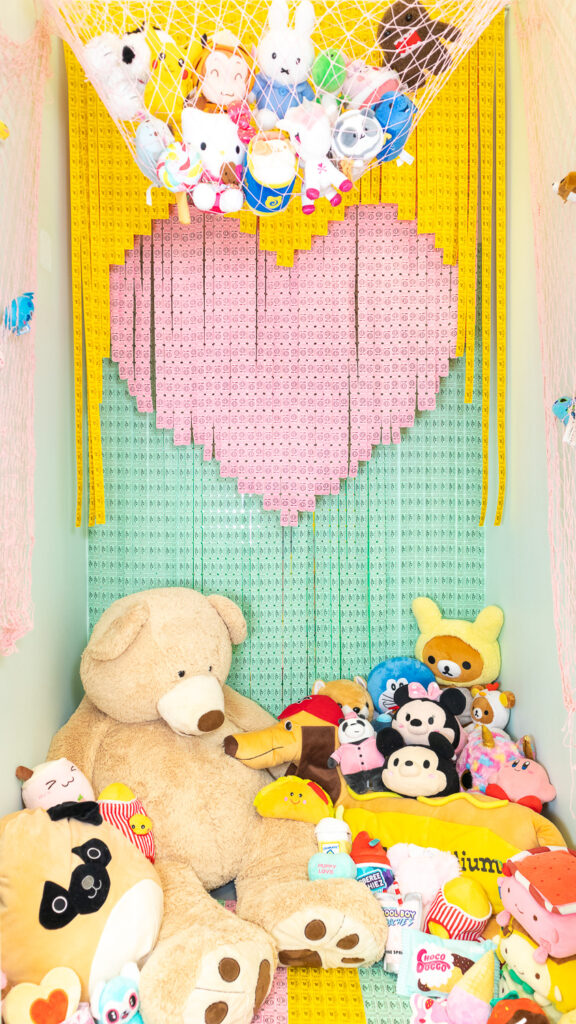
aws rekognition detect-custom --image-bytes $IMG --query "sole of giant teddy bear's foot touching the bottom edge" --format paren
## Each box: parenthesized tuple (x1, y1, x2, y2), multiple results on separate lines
(182, 940, 274, 1024)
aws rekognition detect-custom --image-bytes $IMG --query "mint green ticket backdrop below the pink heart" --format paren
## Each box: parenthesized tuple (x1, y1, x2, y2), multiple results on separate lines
(89, 360, 485, 713)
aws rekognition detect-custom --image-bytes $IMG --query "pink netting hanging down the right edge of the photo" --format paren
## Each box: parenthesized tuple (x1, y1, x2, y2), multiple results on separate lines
(516, 0, 576, 775)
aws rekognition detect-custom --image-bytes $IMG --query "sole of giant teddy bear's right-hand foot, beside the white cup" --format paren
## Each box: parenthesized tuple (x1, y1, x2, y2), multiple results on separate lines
(272, 882, 386, 968)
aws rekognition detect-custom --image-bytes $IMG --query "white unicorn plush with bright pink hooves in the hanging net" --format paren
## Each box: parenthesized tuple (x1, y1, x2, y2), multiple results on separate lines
(278, 99, 353, 213)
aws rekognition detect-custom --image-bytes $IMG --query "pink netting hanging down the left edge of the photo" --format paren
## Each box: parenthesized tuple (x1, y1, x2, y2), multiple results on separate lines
(0, 23, 49, 654)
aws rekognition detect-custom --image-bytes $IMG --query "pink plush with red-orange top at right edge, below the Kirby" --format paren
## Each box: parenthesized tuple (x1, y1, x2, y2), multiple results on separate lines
(496, 846, 576, 964)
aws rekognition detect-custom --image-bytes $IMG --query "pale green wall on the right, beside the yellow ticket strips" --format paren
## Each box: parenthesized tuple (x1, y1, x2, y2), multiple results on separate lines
(486, 16, 576, 842)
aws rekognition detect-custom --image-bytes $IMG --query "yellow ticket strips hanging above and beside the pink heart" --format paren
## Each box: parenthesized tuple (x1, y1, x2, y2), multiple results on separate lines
(61, 12, 506, 526)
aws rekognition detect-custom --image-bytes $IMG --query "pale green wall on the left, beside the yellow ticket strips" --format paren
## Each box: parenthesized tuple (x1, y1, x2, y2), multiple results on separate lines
(0, 9, 86, 815)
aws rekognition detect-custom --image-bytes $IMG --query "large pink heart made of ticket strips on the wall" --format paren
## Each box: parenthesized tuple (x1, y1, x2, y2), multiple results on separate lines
(111, 206, 457, 525)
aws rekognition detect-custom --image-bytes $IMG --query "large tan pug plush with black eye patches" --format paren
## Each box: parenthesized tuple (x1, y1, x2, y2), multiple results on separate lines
(0, 802, 164, 999)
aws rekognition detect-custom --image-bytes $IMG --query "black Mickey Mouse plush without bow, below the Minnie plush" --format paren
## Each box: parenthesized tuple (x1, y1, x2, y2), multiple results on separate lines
(376, 729, 460, 797)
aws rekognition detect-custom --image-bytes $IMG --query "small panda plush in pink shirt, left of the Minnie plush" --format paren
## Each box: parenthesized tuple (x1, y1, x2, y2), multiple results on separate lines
(328, 712, 384, 793)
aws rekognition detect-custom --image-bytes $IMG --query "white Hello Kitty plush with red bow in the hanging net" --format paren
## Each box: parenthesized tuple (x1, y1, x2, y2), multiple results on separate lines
(181, 106, 241, 213)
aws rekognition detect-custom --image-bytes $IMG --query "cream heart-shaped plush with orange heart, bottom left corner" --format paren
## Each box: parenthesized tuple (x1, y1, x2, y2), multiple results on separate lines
(2, 967, 82, 1024)
